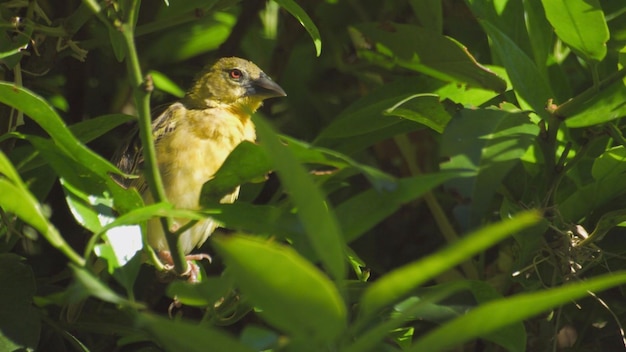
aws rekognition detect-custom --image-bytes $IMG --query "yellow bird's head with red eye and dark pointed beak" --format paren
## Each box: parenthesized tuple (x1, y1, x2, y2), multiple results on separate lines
(186, 57, 287, 112)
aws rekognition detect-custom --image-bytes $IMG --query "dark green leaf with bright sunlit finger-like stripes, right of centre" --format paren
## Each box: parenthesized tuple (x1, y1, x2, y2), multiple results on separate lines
(441, 108, 539, 229)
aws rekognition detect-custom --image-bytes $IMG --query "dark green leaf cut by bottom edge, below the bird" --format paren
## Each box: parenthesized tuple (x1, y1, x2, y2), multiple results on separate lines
(135, 313, 254, 352)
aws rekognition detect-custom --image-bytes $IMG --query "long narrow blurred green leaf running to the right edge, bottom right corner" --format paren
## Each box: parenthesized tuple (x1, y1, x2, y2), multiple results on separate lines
(408, 272, 626, 352)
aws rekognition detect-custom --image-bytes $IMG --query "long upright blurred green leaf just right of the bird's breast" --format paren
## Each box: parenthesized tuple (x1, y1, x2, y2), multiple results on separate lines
(255, 116, 346, 279)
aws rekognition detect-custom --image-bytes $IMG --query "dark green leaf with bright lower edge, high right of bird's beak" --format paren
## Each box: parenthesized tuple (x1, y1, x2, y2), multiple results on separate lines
(354, 23, 506, 92)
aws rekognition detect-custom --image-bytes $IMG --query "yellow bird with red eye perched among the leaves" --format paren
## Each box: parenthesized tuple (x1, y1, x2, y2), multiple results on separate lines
(114, 57, 287, 271)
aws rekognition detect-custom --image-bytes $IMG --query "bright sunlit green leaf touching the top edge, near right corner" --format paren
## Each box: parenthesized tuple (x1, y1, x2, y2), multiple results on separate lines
(541, 0, 609, 61)
